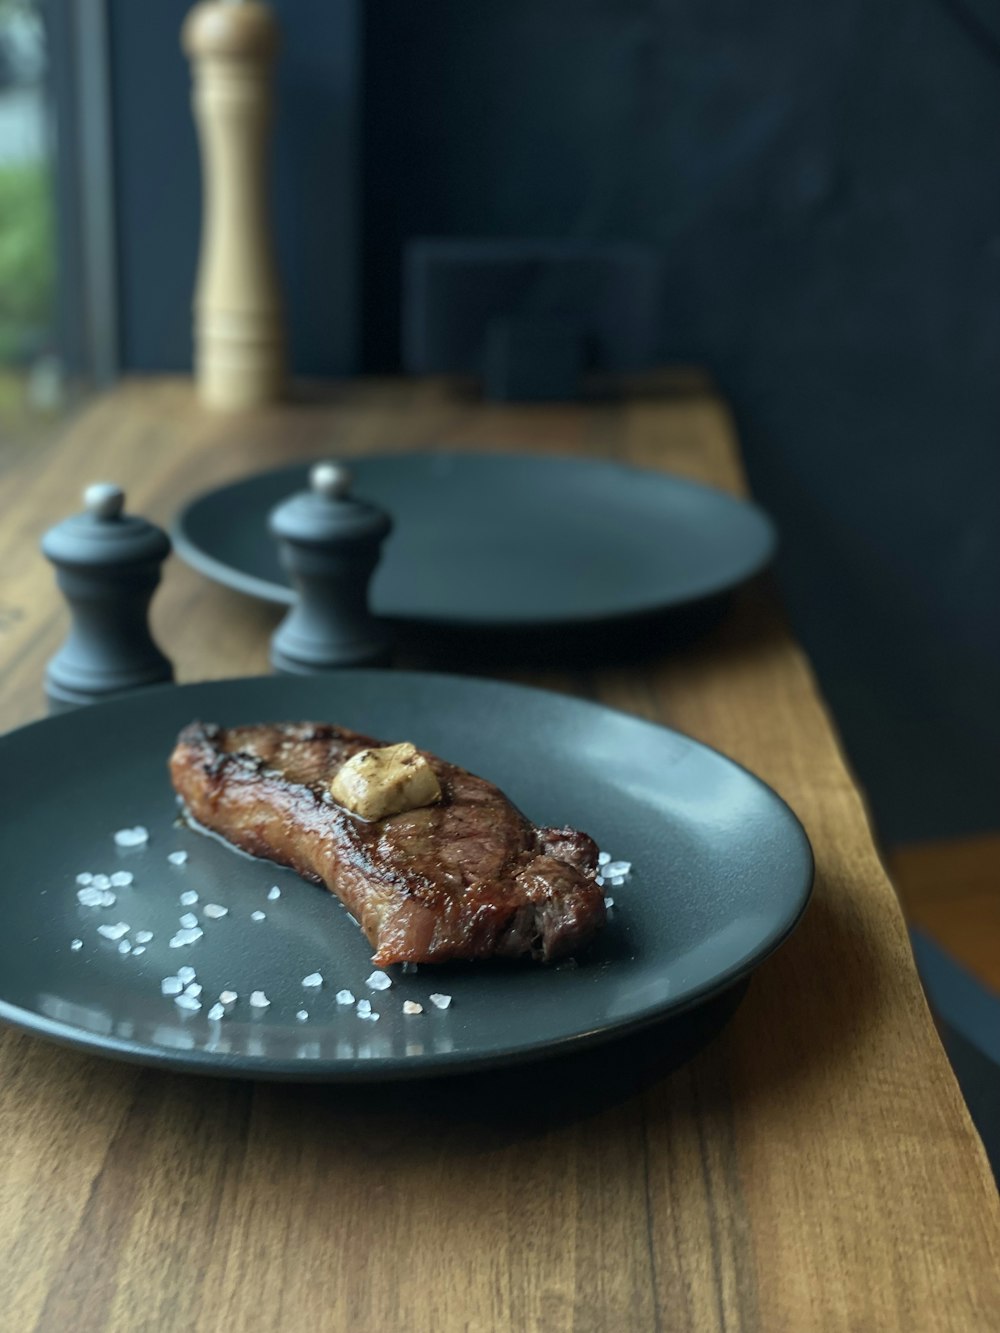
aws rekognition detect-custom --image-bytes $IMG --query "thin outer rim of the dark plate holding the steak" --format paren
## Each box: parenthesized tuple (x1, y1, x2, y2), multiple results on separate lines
(0, 668, 816, 1084)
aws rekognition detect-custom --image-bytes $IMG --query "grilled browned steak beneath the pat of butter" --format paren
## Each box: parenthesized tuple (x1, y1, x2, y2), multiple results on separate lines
(171, 722, 605, 965)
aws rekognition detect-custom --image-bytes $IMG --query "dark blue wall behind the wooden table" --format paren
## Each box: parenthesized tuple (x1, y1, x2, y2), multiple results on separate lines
(112, 0, 1000, 838)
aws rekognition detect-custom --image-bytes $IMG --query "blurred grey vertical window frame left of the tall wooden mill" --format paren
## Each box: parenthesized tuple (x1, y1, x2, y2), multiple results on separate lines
(41, 0, 120, 385)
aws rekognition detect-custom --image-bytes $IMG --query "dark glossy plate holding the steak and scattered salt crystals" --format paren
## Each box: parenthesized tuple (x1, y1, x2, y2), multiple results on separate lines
(0, 672, 812, 1081)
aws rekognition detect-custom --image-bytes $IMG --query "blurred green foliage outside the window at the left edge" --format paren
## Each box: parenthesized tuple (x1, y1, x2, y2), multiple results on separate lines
(0, 163, 55, 363)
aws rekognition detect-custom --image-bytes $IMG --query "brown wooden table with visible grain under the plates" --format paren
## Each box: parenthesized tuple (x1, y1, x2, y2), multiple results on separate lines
(0, 381, 1000, 1333)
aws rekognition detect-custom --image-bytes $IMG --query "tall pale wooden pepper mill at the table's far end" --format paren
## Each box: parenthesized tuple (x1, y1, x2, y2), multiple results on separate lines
(181, 0, 285, 411)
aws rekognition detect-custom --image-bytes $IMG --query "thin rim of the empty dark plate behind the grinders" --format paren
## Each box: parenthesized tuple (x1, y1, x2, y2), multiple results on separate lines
(169, 448, 779, 632)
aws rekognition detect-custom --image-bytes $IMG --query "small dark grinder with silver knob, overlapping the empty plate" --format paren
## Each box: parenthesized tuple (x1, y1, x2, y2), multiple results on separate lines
(268, 463, 392, 674)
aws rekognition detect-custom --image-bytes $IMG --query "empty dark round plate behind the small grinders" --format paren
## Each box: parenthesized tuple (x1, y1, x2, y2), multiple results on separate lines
(173, 453, 775, 628)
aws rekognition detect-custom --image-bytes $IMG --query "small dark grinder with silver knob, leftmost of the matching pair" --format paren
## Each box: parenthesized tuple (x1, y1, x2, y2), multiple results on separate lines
(41, 481, 173, 713)
